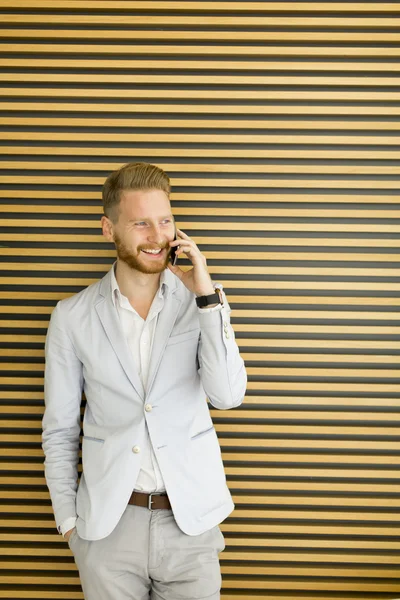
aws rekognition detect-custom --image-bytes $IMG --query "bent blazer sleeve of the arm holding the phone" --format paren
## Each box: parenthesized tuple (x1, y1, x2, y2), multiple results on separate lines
(198, 284, 247, 409)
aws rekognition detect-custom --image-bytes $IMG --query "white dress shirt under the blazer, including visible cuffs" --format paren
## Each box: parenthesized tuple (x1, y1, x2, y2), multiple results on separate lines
(60, 262, 225, 535)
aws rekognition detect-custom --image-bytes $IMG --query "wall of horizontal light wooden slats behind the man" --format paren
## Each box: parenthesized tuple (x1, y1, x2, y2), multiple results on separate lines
(0, 0, 400, 600)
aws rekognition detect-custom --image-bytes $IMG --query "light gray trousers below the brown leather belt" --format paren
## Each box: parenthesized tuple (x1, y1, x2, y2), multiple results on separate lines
(69, 505, 225, 600)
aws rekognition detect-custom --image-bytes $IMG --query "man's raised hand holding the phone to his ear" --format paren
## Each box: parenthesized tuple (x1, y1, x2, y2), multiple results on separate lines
(168, 229, 215, 296)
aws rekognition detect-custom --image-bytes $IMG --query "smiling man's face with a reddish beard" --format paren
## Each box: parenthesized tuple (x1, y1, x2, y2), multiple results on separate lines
(106, 190, 175, 274)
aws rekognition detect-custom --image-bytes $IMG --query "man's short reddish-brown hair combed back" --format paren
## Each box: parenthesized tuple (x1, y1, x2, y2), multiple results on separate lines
(102, 163, 171, 223)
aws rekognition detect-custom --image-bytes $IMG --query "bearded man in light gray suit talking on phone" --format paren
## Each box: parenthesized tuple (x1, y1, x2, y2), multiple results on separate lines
(43, 163, 246, 600)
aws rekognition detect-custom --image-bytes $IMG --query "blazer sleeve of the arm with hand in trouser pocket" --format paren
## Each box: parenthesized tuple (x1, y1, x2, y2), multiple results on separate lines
(42, 302, 83, 531)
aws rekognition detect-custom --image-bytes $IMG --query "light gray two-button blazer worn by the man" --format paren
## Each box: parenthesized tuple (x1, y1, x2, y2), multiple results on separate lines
(43, 270, 246, 540)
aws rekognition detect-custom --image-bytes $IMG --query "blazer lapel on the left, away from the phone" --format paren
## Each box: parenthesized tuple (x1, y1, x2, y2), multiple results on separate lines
(95, 273, 145, 400)
